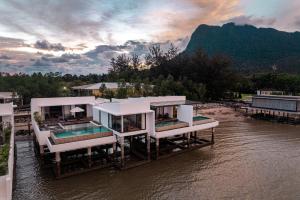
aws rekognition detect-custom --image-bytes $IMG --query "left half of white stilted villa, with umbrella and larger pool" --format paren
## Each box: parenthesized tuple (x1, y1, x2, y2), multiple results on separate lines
(31, 96, 116, 176)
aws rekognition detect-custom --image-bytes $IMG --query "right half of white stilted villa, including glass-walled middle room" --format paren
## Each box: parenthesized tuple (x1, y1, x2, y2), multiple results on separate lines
(93, 96, 219, 167)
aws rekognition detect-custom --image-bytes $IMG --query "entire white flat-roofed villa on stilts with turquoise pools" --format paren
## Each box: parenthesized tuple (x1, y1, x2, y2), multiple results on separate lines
(31, 96, 219, 176)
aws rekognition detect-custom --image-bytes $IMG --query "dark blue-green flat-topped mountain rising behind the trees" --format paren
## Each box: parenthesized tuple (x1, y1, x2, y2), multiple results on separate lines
(184, 23, 300, 72)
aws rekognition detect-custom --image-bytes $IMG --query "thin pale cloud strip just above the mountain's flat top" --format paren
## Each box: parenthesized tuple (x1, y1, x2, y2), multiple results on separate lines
(225, 15, 276, 26)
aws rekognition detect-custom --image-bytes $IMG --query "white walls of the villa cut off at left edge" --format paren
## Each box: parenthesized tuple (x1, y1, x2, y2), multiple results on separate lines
(0, 103, 14, 200)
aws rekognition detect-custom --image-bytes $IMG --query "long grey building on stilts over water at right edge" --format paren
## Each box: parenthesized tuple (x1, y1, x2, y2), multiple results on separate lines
(246, 94, 300, 123)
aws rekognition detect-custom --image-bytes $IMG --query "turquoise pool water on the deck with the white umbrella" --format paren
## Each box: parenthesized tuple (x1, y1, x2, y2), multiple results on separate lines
(55, 126, 110, 138)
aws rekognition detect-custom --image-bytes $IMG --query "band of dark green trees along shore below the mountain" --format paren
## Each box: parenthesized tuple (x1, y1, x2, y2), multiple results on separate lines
(0, 45, 300, 104)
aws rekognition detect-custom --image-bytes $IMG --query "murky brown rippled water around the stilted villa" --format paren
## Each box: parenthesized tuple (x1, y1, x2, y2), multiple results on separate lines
(14, 119, 300, 200)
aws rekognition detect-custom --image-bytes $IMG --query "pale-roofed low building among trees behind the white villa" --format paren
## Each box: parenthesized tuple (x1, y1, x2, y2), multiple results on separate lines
(72, 82, 132, 97)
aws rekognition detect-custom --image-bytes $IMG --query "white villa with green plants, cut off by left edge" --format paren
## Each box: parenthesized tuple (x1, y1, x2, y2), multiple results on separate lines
(0, 103, 14, 200)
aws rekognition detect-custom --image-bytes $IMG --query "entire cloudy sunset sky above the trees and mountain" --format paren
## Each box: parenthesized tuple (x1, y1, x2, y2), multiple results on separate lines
(0, 0, 300, 74)
